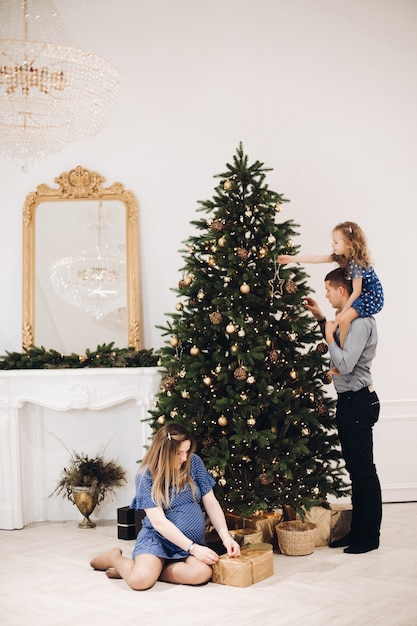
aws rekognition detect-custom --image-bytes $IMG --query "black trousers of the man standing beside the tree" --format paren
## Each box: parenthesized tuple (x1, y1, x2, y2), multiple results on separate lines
(336, 387, 382, 545)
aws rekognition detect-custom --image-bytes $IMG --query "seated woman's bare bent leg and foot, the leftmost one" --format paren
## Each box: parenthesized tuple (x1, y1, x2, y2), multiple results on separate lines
(90, 548, 164, 590)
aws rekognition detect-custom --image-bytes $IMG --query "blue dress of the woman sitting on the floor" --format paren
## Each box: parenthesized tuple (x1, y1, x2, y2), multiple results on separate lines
(130, 454, 216, 559)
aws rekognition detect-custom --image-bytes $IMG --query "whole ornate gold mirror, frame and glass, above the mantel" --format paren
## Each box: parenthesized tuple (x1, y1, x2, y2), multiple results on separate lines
(22, 165, 142, 354)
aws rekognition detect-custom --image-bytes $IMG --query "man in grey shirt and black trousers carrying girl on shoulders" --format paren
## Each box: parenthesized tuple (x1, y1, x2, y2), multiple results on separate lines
(306, 268, 382, 554)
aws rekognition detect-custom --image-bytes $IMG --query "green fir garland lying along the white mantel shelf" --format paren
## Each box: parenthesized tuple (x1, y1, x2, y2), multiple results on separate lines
(0, 342, 159, 370)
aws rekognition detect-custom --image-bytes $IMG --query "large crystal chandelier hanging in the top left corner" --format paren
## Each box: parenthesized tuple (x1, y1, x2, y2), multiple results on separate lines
(0, 0, 120, 167)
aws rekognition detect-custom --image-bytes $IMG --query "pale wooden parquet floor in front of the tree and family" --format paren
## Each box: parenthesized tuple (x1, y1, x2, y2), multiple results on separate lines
(0, 503, 417, 626)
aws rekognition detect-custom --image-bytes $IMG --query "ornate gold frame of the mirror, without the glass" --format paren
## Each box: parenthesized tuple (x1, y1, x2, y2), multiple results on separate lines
(22, 165, 142, 350)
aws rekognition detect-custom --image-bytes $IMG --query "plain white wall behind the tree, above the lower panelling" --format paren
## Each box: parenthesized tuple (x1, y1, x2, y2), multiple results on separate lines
(0, 0, 417, 498)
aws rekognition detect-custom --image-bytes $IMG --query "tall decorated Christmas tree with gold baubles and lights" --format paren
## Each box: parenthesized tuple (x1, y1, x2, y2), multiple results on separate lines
(150, 145, 346, 515)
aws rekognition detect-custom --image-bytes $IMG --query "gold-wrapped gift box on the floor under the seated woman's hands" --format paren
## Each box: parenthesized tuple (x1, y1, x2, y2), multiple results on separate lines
(213, 547, 274, 587)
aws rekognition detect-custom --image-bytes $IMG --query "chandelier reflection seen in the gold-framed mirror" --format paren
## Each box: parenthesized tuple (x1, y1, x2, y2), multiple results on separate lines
(51, 202, 127, 320)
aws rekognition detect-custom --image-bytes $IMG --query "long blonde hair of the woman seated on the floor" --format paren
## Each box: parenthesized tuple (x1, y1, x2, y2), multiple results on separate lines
(139, 422, 197, 508)
